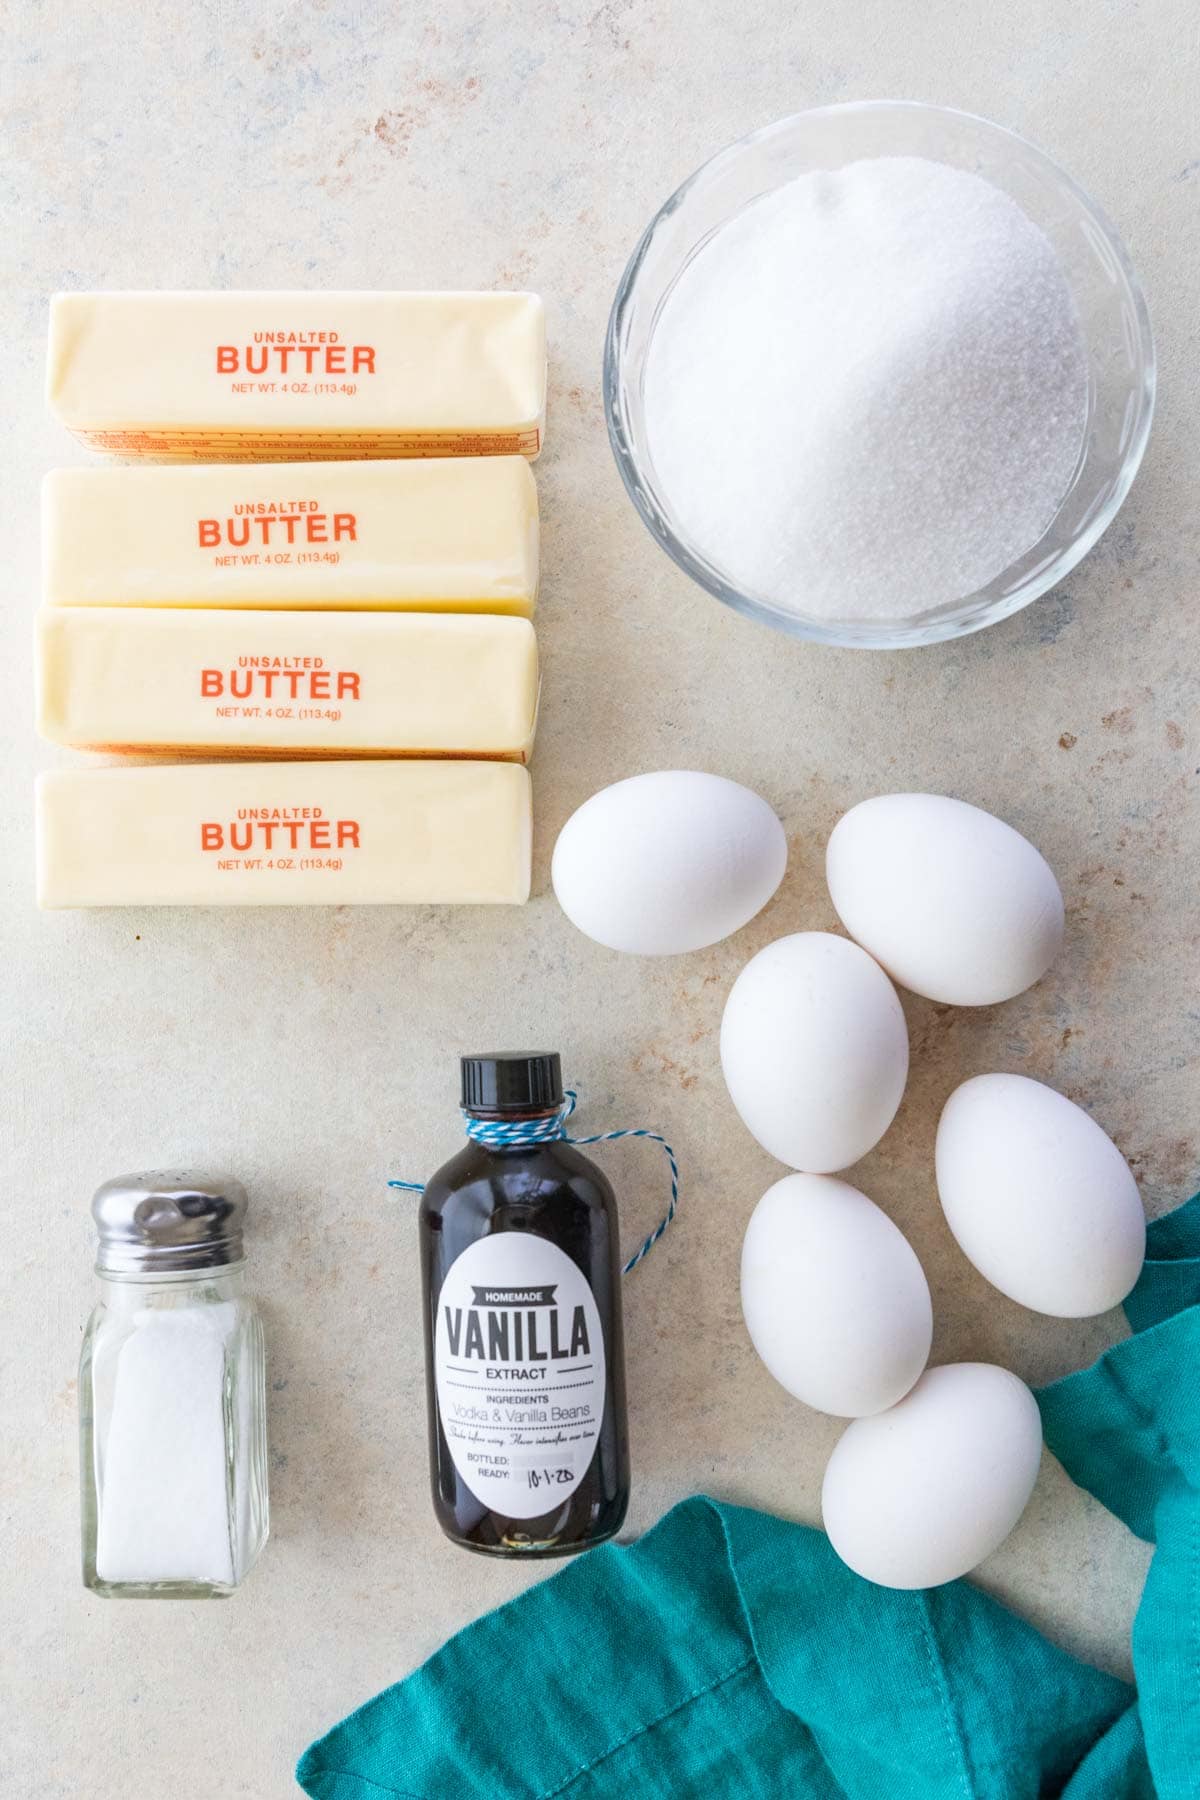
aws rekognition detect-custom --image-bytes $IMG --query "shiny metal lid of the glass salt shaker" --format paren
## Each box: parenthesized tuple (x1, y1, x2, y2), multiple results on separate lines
(92, 1170, 246, 1274)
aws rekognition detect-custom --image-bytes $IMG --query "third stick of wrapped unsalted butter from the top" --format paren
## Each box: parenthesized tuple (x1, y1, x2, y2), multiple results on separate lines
(38, 607, 538, 761)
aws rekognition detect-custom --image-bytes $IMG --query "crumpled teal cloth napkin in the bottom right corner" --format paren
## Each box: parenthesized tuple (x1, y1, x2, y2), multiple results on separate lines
(297, 1195, 1200, 1800)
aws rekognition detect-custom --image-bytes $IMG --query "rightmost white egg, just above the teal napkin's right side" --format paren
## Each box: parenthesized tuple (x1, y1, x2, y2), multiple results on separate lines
(937, 1075, 1146, 1319)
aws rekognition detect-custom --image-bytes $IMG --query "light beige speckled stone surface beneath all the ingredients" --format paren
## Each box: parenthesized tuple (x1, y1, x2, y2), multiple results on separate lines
(0, 0, 1200, 1800)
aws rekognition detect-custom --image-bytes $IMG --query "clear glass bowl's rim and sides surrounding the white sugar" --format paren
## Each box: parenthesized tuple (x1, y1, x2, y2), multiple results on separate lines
(604, 101, 1155, 650)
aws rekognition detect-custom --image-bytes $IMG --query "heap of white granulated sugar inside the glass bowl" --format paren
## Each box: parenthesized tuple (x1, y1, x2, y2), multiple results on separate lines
(644, 157, 1087, 621)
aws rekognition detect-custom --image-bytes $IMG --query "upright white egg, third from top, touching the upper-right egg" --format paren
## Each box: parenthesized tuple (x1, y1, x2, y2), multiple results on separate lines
(721, 931, 909, 1175)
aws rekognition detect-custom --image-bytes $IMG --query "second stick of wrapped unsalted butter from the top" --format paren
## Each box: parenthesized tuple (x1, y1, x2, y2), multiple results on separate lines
(41, 457, 538, 617)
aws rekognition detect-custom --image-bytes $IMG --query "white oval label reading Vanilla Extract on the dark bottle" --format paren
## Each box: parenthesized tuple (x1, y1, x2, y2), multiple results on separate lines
(434, 1231, 604, 1519)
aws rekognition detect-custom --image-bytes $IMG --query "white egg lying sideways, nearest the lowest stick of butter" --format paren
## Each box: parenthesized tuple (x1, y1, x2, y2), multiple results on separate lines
(552, 769, 788, 956)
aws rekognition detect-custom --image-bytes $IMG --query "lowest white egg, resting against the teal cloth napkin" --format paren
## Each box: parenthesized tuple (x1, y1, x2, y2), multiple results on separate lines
(820, 1363, 1042, 1588)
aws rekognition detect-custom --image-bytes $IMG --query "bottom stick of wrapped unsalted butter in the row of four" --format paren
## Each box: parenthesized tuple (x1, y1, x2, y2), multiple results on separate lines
(38, 761, 531, 907)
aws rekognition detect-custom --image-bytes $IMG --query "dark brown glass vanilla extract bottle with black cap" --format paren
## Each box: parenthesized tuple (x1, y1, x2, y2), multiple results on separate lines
(421, 1053, 630, 1557)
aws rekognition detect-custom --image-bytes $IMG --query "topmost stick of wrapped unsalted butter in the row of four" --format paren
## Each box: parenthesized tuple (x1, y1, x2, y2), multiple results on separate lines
(47, 292, 545, 463)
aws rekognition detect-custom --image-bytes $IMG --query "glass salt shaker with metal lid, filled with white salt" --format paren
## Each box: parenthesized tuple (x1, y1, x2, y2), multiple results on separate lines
(79, 1172, 268, 1598)
